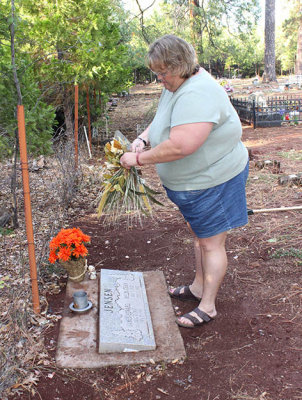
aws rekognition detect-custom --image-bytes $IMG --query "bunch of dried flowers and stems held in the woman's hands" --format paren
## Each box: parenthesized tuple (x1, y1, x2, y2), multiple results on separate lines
(97, 138, 163, 223)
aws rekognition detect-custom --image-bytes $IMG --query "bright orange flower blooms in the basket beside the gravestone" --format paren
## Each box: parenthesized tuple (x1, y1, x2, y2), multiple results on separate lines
(48, 228, 90, 264)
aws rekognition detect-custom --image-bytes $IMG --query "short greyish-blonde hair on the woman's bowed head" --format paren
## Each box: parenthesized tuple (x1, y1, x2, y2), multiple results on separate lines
(147, 35, 198, 78)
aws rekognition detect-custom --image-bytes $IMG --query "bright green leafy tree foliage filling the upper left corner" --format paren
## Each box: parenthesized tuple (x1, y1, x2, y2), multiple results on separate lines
(0, 0, 131, 157)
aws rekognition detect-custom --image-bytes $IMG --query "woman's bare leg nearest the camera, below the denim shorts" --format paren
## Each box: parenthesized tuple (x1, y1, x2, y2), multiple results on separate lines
(179, 232, 227, 326)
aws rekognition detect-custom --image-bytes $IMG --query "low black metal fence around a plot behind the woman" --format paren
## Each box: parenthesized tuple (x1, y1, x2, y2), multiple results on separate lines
(230, 96, 302, 129)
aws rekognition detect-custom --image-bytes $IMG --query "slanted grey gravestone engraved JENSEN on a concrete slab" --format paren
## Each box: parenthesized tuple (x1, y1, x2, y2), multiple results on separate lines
(99, 269, 156, 353)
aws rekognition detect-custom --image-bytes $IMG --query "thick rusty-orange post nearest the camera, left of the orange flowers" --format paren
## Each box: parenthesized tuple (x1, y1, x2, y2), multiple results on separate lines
(17, 105, 40, 314)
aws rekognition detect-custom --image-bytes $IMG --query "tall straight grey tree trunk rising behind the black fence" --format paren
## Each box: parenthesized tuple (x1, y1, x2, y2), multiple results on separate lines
(263, 0, 277, 83)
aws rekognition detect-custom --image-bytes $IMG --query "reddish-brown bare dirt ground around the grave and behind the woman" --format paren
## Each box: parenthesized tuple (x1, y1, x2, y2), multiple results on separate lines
(9, 86, 302, 400)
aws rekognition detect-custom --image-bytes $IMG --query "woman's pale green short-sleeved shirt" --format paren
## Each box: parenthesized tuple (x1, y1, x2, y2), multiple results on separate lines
(149, 70, 248, 190)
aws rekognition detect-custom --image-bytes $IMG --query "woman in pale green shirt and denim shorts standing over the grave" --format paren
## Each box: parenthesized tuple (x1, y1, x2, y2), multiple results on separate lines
(121, 35, 248, 328)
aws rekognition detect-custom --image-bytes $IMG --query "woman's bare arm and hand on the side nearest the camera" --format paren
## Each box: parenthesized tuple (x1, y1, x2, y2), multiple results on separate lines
(121, 122, 213, 168)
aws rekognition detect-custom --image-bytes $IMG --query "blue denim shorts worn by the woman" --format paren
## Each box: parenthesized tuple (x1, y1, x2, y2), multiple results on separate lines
(165, 163, 249, 238)
